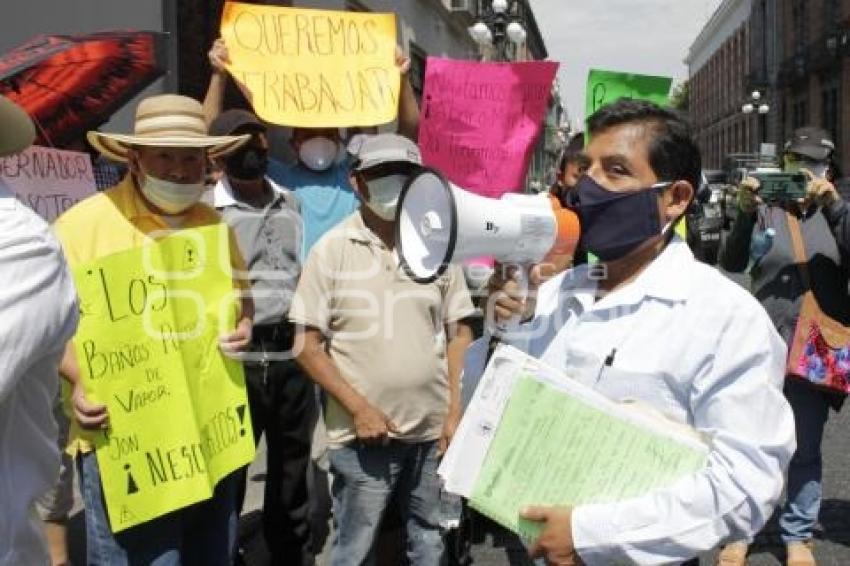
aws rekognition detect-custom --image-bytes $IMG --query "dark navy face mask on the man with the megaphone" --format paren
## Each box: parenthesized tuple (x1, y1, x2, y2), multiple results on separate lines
(572, 175, 672, 261)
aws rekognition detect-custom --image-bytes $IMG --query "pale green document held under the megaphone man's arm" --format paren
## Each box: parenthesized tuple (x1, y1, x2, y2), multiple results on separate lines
(470, 374, 707, 539)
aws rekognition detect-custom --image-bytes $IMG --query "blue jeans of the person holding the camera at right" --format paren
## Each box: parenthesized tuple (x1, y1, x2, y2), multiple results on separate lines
(779, 379, 830, 543)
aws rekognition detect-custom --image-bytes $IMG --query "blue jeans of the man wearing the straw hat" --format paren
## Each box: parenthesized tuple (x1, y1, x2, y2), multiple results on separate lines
(79, 452, 238, 566)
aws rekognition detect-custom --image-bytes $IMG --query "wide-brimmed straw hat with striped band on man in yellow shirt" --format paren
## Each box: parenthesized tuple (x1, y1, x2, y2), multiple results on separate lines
(88, 94, 250, 161)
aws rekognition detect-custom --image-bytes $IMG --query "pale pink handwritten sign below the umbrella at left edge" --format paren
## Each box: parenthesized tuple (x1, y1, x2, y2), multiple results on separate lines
(0, 146, 95, 222)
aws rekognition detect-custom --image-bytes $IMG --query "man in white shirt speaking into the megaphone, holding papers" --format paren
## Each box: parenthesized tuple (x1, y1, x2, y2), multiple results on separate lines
(484, 99, 795, 565)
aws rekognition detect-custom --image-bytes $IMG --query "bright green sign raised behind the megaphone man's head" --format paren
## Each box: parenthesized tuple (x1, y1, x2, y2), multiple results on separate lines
(584, 69, 673, 120)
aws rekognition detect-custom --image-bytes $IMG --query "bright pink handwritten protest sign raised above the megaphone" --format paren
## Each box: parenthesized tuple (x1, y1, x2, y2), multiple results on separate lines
(419, 57, 558, 197)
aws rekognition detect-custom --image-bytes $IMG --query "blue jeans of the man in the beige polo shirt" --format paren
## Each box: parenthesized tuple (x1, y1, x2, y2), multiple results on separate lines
(329, 440, 444, 566)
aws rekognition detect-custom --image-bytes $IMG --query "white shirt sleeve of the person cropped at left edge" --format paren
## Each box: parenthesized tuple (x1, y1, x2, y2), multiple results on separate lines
(0, 204, 79, 403)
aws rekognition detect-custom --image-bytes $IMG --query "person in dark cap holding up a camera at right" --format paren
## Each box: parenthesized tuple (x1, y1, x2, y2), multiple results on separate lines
(720, 127, 850, 566)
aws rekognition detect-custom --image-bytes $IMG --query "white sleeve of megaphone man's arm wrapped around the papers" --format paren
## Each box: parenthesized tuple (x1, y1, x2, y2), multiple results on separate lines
(572, 302, 795, 566)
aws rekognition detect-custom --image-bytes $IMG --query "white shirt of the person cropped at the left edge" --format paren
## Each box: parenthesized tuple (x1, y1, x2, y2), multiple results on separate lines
(0, 186, 79, 566)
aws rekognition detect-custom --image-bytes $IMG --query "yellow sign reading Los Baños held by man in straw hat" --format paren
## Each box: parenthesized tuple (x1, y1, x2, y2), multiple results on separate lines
(74, 225, 254, 532)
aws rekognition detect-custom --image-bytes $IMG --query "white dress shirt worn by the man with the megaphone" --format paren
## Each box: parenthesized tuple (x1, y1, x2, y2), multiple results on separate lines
(464, 237, 795, 566)
